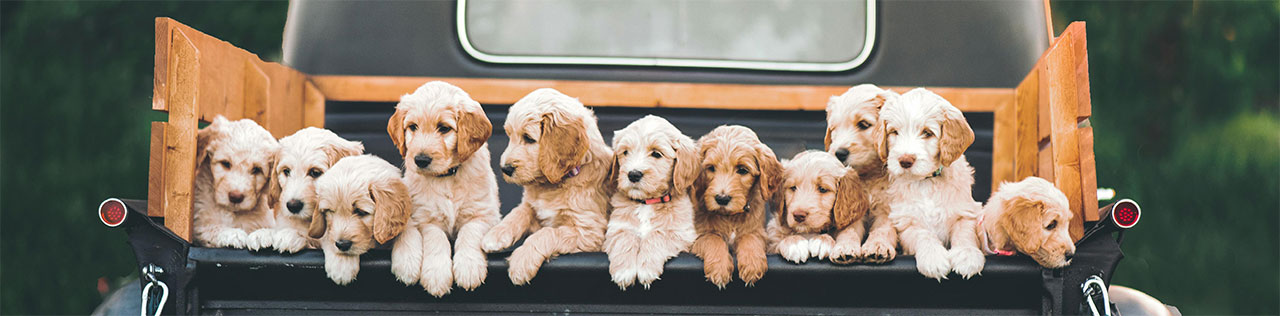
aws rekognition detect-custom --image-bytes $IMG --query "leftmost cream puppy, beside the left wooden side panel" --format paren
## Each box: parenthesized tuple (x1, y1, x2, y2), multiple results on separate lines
(193, 115, 280, 248)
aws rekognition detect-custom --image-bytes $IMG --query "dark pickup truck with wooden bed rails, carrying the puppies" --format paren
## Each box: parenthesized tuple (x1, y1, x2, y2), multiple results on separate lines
(99, 0, 1162, 315)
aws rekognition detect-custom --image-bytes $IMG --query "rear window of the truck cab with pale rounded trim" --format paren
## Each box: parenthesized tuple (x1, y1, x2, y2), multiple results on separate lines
(457, 0, 876, 72)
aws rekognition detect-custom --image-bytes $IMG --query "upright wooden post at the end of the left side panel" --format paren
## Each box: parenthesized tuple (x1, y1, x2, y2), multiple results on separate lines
(163, 29, 201, 241)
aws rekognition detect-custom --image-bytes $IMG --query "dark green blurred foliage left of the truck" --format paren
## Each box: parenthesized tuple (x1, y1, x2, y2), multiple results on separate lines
(0, 1, 288, 315)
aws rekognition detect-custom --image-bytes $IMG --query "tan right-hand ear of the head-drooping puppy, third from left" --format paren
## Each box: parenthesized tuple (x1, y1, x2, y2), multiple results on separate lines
(369, 178, 410, 243)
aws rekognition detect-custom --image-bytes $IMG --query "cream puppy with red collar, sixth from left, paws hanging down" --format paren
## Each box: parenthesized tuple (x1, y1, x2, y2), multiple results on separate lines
(604, 115, 701, 290)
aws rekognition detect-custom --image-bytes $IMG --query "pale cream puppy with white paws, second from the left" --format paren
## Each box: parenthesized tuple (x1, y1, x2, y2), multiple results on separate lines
(247, 127, 365, 253)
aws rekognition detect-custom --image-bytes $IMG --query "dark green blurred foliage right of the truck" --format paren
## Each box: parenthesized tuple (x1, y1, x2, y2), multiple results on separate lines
(1053, 1, 1280, 315)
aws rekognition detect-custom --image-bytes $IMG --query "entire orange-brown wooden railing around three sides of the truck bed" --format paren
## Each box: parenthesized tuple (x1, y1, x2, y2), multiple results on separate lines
(148, 18, 1097, 241)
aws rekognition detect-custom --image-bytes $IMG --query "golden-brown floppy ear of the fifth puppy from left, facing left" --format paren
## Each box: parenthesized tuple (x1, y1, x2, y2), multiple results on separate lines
(538, 110, 590, 184)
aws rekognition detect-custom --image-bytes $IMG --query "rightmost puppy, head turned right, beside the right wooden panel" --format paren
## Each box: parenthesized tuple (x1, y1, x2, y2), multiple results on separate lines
(978, 177, 1075, 269)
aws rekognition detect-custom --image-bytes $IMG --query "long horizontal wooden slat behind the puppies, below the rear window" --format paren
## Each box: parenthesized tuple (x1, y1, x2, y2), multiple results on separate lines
(310, 75, 1012, 113)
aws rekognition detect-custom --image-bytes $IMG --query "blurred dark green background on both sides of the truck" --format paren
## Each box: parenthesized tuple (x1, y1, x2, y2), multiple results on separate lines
(0, 1, 1280, 315)
